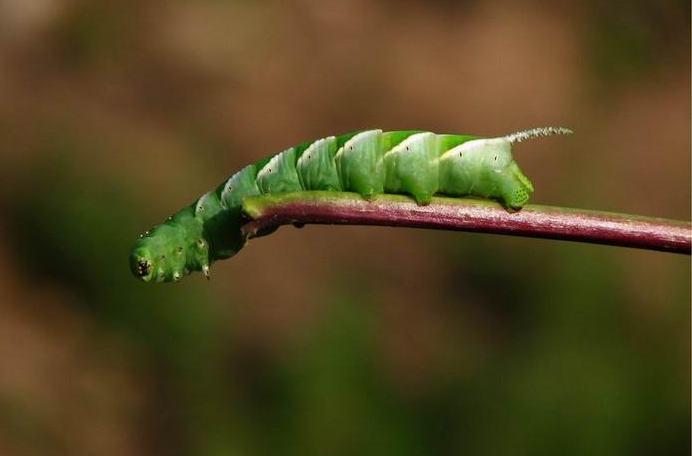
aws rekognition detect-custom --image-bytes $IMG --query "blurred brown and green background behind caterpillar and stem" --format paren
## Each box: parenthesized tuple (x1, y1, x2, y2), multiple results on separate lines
(0, 0, 690, 456)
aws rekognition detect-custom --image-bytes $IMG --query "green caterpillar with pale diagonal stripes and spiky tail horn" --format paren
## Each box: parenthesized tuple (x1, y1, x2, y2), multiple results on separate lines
(130, 127, 572, 282)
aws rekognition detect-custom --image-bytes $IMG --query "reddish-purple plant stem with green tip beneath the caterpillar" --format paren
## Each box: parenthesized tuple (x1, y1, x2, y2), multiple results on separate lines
(242, 191, 692, 255)
